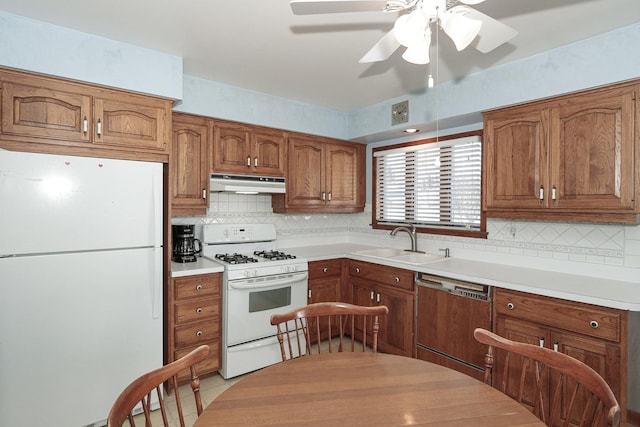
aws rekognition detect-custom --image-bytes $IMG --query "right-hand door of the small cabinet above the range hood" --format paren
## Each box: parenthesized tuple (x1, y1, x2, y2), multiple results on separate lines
(251, 128, 286, 176)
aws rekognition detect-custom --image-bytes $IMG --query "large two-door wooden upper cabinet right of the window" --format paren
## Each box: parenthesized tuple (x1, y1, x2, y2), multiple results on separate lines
(483, 82, 640, 223)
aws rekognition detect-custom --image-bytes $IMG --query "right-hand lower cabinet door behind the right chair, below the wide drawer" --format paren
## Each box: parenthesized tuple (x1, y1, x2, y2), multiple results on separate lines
(549, 332, 621, 426)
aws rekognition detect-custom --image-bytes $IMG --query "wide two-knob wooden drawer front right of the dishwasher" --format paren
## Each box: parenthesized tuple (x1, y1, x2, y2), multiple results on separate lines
(494, 289, 620, 342)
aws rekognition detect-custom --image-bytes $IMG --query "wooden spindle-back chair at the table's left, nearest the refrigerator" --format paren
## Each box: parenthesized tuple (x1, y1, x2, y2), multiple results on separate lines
(107, 345, 209, 427)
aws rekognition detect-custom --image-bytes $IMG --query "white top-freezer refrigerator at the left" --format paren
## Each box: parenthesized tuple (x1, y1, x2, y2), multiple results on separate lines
(0, 150, 163, 427)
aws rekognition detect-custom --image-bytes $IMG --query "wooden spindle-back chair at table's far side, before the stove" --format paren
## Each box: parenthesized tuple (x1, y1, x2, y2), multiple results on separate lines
(271, 302, 389, 361)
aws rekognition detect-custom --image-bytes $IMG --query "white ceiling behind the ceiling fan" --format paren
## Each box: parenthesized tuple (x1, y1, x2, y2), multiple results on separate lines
(0, 0, 640, 111)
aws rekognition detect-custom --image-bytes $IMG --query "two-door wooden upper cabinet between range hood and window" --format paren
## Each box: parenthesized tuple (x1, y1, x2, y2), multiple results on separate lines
(272, 134, 365, 213)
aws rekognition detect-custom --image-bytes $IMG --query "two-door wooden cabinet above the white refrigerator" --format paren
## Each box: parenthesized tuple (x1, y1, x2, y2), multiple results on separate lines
(0, 70, 172, 159)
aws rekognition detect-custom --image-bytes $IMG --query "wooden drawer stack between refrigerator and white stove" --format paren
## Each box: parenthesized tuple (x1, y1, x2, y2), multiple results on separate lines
(165, 273, 222, 383)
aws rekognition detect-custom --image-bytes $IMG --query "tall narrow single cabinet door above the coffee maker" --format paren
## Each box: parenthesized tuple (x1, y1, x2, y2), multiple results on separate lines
(171, 115, 210, 214)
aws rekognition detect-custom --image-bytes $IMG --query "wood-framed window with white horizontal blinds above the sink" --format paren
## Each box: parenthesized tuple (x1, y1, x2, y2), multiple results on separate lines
(373, 133, 486, 237)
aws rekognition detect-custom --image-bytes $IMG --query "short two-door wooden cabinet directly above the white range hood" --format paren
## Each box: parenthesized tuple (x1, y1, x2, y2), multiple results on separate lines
(211, 121, 286, 176)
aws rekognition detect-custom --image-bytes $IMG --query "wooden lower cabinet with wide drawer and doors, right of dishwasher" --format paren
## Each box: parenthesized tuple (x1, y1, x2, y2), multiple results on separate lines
(492, 289, 628, 426)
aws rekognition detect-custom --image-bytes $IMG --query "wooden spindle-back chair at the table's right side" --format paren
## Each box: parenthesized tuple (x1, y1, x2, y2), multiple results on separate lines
(473, 328, 620, 427)
